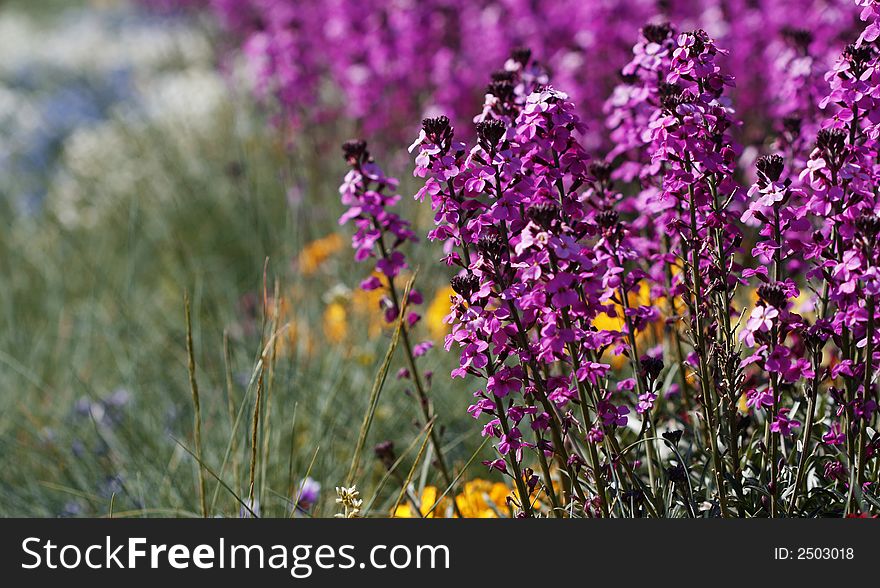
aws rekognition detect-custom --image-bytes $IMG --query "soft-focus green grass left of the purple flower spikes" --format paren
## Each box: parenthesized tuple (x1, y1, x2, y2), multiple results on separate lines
(0, 81, 488, 516)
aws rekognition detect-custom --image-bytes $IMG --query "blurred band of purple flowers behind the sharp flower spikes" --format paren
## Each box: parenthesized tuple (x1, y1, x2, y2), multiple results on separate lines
(186, 0, 854, 149)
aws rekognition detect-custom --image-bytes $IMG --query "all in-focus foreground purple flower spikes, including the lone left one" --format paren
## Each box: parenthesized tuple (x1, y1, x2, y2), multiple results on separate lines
(326, 1, 880, 517)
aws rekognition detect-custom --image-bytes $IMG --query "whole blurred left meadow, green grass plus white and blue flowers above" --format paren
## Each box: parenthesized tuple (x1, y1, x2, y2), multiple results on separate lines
(0, 0, 474, 517)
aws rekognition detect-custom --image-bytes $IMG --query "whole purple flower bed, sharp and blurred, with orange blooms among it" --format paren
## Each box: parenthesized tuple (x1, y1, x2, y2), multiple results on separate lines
(15, 0, 880, 518)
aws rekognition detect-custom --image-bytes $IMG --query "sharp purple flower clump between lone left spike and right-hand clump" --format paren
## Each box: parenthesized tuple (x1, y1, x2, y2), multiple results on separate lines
(411, 48, 692, 514)
